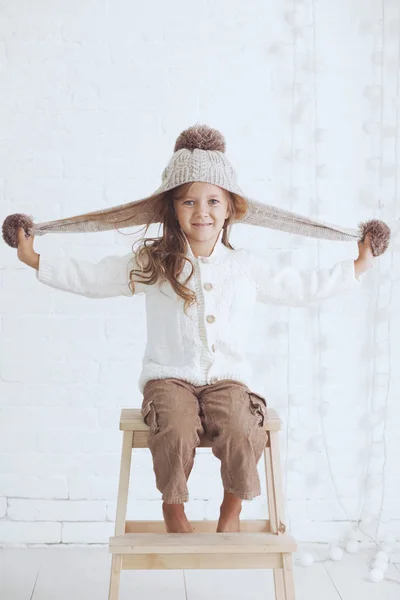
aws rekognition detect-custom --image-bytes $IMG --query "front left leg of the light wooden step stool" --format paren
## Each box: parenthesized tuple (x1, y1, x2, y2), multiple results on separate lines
(108, 431, 133, 600)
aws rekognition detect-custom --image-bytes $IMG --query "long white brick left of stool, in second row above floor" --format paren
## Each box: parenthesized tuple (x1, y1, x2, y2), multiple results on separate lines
(7, 498, 106, 522)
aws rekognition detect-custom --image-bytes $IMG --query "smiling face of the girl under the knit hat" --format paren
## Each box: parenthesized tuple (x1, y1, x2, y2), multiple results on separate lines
(174, 181, 229, 245)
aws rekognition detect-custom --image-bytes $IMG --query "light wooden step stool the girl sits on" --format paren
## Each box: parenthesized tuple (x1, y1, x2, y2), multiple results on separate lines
(108, 408, 297, 600)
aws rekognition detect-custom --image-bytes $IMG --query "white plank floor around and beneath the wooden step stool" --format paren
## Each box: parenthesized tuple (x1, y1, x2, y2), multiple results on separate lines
(0, 545, 400, 600)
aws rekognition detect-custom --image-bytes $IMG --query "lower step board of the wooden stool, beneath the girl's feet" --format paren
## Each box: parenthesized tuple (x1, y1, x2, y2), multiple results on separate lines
(109, 533, 297, 555)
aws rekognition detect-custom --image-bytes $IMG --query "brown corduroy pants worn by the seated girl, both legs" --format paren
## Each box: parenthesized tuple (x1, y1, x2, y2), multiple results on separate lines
(142, 378, 267, 504)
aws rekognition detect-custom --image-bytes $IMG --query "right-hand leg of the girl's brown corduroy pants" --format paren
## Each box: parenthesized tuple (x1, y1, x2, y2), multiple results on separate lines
(198, 380, 267, 500)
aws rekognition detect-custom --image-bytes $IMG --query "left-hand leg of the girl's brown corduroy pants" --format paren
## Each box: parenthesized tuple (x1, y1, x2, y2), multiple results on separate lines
(142, 378, 204, 504)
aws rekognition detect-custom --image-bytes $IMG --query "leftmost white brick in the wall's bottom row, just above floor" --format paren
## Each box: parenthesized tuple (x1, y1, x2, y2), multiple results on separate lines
(0, 521, 61, 545)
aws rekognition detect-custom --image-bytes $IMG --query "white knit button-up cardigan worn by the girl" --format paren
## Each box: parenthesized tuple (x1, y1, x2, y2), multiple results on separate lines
(37, 236, 361, 391)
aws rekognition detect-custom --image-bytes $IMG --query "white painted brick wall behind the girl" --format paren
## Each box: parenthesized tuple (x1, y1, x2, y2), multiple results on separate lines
(0, 0, 400, 545)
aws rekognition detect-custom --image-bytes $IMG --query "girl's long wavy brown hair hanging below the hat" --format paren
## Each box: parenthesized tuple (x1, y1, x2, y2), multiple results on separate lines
(129, 183, 247, 312)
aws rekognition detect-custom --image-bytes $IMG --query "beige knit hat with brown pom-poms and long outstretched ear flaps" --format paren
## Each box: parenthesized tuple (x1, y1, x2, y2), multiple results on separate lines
(2, 125, 400, 256)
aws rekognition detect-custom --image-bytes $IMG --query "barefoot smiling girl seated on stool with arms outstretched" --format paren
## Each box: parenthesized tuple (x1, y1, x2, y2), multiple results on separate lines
(14, 124, 373, 533)
